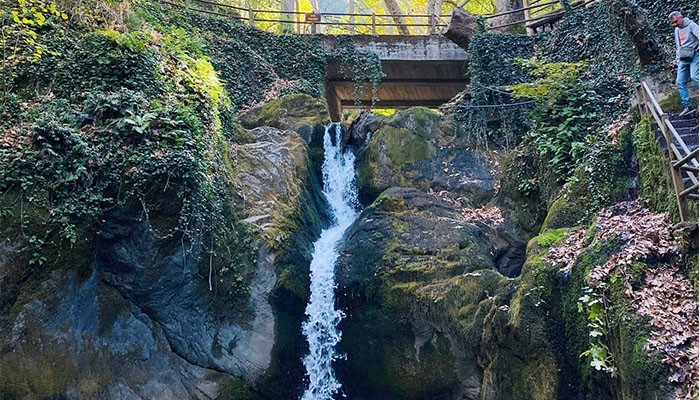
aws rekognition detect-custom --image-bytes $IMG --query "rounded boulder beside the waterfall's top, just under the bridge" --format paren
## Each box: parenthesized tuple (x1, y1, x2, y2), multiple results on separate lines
(357, 107, 496, 206)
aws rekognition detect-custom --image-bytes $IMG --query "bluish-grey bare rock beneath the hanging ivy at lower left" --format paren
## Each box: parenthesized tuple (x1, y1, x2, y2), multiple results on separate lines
(0, 199, 276, 399)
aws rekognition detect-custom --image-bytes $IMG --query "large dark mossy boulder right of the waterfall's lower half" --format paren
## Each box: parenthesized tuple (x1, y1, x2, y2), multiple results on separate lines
(336, 188, 532, 399)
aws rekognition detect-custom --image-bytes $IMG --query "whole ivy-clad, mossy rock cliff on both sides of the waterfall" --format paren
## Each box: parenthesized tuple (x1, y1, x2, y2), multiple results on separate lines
(0, 2, 698, 400)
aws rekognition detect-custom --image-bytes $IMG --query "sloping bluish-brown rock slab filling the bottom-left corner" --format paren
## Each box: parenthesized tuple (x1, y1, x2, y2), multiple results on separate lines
(0, 241, 227, 399)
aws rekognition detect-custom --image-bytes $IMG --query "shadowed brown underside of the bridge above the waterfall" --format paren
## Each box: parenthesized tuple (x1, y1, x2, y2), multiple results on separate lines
(326, 60, 467, 121)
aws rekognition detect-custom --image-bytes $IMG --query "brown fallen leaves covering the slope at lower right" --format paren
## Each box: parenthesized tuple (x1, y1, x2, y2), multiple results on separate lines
(546, 202, 699, 400)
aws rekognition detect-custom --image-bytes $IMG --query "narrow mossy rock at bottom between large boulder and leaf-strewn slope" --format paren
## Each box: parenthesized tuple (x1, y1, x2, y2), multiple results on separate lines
(480, 253, 561, 400)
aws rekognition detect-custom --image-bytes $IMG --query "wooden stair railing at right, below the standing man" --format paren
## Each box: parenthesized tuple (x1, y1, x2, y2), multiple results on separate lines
(637, 82, 700, 223)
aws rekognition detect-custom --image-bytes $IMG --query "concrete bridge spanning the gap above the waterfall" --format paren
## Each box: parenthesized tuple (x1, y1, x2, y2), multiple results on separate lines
(321, 35, 467, 121)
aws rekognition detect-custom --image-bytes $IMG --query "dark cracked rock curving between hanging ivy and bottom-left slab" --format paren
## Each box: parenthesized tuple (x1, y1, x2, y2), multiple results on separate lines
(95, 211, 276, 383)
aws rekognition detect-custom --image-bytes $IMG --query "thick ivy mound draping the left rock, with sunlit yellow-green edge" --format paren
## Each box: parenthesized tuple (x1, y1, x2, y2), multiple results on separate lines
(0, 14, 255, 304)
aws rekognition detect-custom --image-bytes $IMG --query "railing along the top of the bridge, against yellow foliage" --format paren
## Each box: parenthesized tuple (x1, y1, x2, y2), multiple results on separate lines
(158, 0, 597, 36)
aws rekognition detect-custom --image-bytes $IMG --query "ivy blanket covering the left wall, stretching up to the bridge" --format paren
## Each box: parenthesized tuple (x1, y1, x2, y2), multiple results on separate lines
(0, 2, 334, 307)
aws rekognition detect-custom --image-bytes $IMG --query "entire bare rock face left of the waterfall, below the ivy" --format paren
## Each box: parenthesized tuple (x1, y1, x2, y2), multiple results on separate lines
(0, 118, 321, 399)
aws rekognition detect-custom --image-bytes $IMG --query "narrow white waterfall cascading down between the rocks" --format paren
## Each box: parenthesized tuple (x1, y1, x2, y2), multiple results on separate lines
(301, 124, 358, 400)
